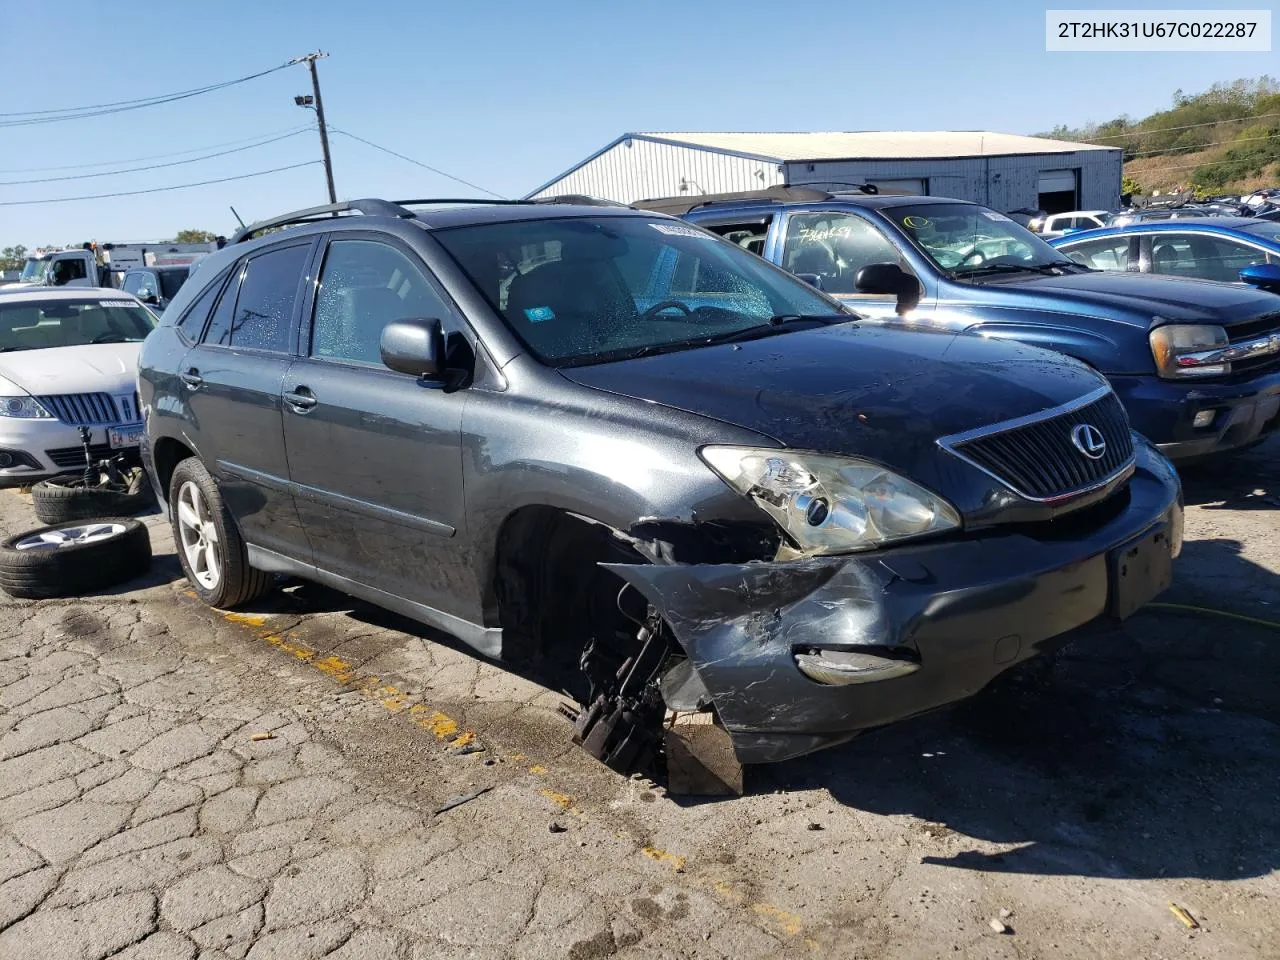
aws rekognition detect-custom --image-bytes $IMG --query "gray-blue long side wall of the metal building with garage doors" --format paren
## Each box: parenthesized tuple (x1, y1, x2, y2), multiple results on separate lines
(783, 150, 1121, 210)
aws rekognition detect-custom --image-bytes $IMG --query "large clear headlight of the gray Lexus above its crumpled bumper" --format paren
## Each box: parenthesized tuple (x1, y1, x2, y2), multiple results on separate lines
(700, 447, 960, 556)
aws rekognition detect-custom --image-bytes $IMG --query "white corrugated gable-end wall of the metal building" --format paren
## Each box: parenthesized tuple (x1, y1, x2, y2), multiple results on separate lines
(532, 140, 783, 204)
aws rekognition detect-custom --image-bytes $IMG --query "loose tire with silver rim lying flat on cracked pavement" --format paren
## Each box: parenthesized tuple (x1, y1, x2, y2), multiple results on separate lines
(0, 517, 151, 599)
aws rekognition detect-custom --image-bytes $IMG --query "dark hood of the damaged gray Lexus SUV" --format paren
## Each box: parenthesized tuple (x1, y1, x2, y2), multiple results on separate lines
(561, 324, 1103, 481)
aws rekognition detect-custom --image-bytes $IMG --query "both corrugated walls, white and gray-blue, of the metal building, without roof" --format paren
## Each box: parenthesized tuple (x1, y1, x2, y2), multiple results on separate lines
(532, 138, 1121, 210)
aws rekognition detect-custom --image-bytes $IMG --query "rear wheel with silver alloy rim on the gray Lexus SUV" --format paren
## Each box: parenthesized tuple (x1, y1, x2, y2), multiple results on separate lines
(169, 457, 275, 609)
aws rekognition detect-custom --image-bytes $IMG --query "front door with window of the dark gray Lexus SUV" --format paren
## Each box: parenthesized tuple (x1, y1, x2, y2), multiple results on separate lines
(284, 233, 467, 612)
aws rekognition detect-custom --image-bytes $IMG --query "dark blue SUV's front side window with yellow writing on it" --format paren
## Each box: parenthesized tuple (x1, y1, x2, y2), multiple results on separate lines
(782, 214, 906, 293)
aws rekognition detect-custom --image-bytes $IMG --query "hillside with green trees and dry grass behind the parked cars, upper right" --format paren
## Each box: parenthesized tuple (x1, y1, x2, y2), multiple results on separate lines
(1041, 77, 1280, 195)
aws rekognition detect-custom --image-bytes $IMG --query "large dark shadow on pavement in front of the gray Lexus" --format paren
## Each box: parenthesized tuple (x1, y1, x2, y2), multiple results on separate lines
(754, 540, 1280, 879)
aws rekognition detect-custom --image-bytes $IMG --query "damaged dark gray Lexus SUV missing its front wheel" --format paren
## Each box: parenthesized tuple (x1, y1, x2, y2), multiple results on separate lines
(140, 198, 1181, 769)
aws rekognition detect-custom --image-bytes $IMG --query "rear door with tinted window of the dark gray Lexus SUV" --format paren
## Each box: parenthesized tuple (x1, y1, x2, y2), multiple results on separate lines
(179, 239, 314, 562)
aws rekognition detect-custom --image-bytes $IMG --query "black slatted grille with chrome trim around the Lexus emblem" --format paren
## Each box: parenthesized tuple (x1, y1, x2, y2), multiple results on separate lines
(938, 387, 1133, 500)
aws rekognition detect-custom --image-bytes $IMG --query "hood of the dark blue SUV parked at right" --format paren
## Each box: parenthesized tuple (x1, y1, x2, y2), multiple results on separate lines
(980, 271, 1280, 329)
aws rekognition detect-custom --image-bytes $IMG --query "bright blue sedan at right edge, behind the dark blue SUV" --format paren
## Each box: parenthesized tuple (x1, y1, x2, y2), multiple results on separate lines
(1050, 216, 1280, 292)
